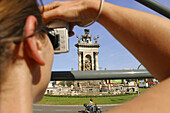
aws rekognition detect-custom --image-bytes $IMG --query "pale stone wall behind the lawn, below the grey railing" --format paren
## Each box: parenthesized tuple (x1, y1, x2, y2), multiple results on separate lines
(45, 84, 138, 96)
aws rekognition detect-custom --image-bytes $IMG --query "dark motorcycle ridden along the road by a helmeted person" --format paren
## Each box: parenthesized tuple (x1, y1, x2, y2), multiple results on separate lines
(84, 104, 102, 113)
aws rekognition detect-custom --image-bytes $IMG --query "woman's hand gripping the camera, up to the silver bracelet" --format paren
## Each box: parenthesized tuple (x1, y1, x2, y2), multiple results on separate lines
(40, 0, 100, 25)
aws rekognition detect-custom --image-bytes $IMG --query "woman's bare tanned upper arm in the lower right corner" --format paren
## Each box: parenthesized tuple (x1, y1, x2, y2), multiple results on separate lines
(106, 78, 170, 113)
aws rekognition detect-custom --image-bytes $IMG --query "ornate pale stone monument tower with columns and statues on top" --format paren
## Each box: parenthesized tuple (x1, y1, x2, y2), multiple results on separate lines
(75, 29, 100, 71)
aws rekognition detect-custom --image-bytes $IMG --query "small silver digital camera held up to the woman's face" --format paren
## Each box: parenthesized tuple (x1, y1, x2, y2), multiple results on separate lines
(47, 20, 69, 54)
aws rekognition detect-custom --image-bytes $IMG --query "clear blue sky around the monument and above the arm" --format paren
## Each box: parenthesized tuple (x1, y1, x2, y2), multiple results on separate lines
(43, 0, 170, 71)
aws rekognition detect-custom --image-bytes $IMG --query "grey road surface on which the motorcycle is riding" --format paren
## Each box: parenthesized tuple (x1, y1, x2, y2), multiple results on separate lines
(33, 105, 117, 113)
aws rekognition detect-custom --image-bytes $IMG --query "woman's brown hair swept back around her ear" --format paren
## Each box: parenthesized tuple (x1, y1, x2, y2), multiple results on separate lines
(0, 0, 44, 81)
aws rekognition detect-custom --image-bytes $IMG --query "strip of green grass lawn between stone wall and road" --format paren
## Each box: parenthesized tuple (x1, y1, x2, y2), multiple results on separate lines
(38, 89, 146, 105)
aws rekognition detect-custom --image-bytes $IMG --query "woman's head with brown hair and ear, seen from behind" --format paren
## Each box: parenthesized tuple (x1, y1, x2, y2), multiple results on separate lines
(0, 0, 53, 100)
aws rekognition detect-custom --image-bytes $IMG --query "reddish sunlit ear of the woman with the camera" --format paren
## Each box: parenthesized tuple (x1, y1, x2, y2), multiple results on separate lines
(25, 15, 45, 65)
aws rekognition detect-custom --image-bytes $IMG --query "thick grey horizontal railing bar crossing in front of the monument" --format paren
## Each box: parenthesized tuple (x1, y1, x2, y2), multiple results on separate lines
(51, 70, 153, 81)
